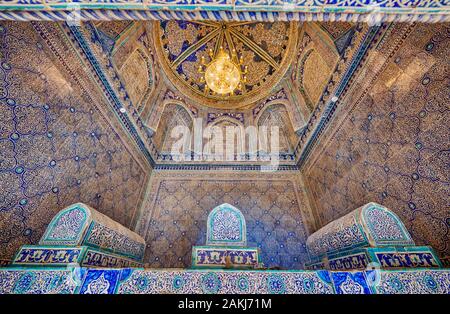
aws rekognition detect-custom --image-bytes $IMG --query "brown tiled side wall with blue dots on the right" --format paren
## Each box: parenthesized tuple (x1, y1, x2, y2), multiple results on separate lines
(303, 24, 450, 257)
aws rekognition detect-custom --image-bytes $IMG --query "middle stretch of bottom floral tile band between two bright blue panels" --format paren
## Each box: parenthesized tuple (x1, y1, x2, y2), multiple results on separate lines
(117, 270, 333, 294)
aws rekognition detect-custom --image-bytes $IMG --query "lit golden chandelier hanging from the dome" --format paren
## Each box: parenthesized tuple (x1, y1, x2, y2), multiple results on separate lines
(198, 46, 248, 95)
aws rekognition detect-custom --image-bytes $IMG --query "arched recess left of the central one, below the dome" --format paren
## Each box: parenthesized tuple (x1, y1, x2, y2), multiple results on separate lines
(153, 101, 194, 153)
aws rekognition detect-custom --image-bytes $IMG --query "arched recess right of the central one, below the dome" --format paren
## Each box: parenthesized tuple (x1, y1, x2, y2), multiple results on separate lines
(255, 102, 298, 153)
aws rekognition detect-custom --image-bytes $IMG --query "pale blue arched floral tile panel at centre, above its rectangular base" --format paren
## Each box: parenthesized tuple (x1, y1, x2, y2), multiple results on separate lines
(206, 203, 247, 246)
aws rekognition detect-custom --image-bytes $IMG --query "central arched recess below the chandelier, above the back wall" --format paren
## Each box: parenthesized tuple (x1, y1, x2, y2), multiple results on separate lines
(207, 116, 246, 157)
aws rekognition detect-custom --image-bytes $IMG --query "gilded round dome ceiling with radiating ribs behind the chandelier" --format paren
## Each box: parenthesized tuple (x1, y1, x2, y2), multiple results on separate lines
(153, 20, 298, 109)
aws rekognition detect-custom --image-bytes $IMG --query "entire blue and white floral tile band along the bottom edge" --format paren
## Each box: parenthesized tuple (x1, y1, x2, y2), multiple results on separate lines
(0, 268, 450, 294)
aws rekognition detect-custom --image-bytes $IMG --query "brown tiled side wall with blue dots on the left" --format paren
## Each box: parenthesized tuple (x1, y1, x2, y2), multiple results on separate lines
(0, 22, 149, 259)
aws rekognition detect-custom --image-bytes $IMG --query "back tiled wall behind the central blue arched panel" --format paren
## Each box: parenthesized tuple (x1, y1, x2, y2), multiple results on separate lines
(140, 171, 310, 269)
